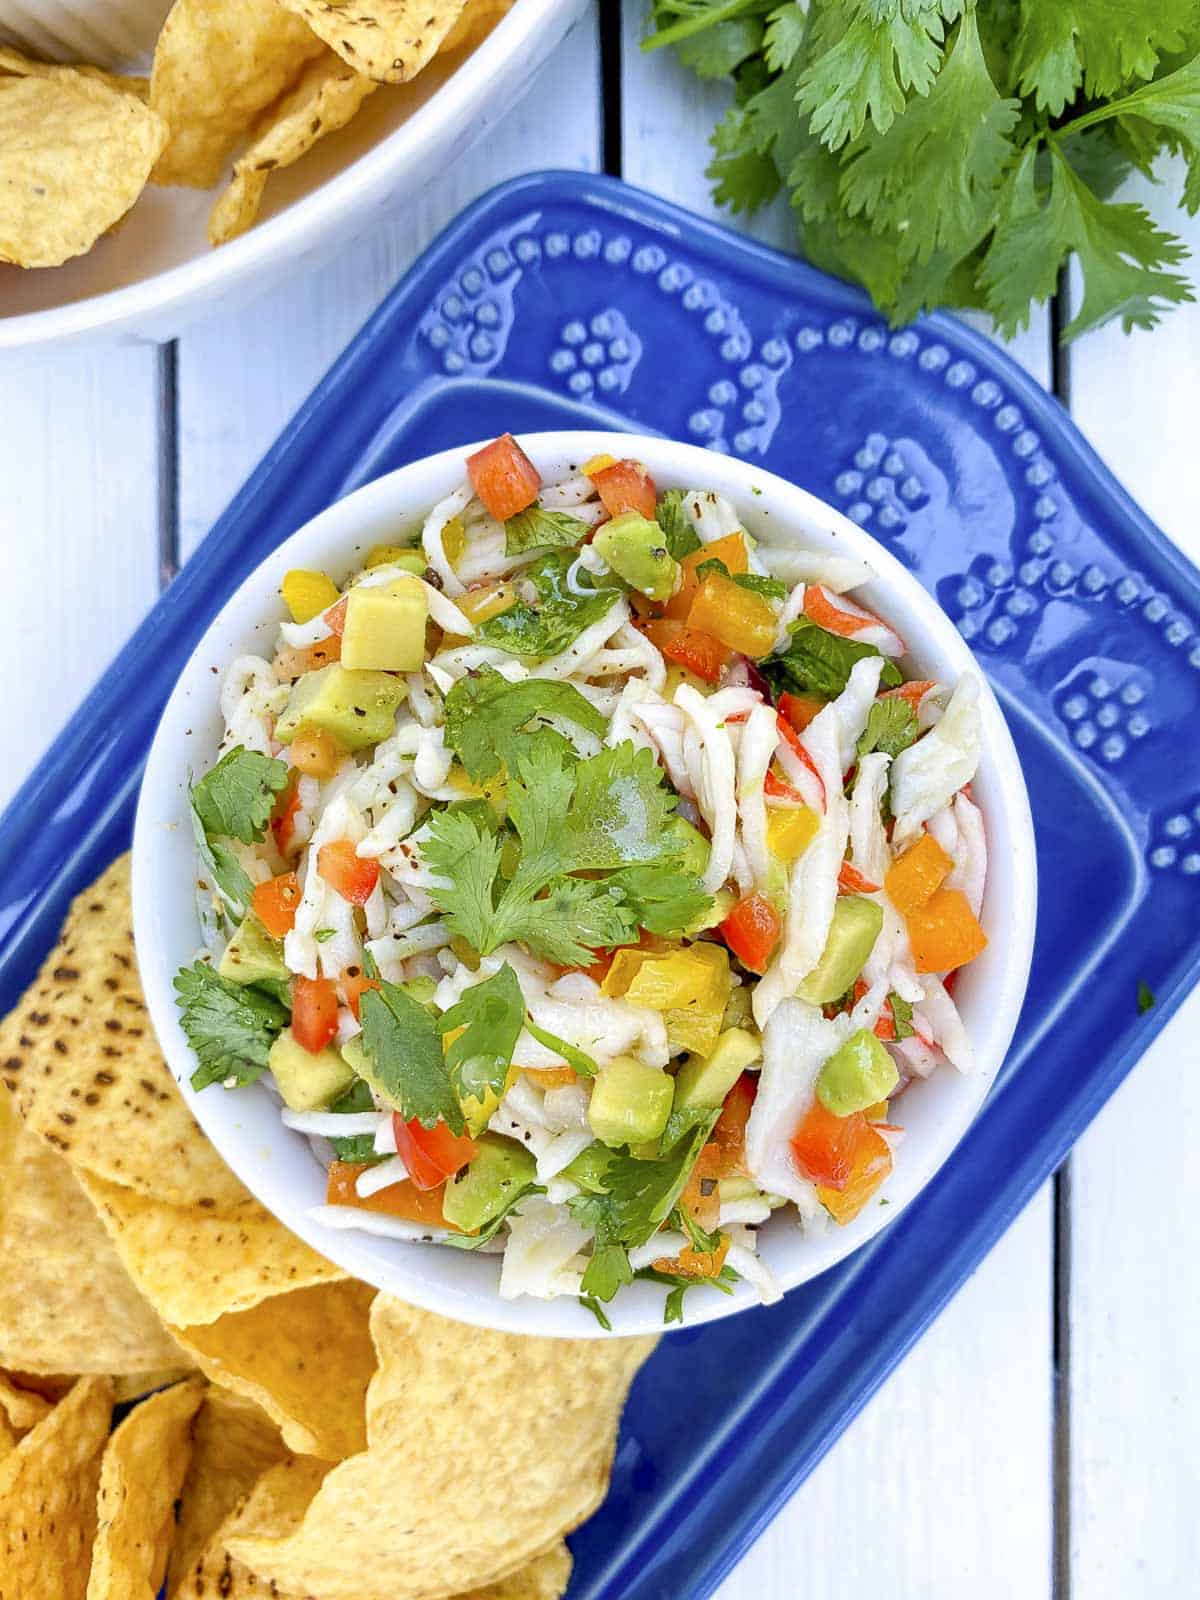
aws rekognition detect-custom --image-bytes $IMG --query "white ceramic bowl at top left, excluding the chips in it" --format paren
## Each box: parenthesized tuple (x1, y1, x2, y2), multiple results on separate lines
(0, 0, 587, 350)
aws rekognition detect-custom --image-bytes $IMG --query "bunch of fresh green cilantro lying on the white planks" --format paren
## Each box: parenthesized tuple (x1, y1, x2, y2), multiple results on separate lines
(645, 0, 1200, 339)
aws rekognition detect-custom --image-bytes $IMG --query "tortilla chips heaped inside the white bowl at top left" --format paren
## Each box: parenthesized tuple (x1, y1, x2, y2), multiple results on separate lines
(0, 0, 512, 267)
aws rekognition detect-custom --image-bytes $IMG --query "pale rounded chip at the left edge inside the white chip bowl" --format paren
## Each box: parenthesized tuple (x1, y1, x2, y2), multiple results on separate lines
(0, 72, 166, 267)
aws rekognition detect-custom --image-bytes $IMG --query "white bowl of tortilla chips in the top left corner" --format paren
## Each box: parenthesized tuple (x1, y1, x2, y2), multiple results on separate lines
(0, 0, 584, 349)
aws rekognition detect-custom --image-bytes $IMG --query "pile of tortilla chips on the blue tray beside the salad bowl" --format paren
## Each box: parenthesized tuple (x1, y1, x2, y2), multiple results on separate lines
(0, 859, 653, 1600)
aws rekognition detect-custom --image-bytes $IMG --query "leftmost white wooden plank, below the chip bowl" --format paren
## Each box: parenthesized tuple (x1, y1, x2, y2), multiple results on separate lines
(0, 349, 158, 806)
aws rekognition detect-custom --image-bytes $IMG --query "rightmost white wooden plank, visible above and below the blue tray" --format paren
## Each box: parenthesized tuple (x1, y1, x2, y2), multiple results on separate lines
(1070, 166, 1200, 1600)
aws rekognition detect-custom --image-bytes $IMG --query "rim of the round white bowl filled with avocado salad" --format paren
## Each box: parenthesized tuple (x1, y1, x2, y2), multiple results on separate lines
(133, 429, 1037, 1338)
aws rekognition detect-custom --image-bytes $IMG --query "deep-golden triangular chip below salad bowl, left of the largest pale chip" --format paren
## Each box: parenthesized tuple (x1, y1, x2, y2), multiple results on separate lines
(173, 1280, 374, 1461)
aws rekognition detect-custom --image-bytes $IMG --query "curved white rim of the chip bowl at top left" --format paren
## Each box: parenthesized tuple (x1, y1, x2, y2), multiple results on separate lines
(0, 0, 586, 350)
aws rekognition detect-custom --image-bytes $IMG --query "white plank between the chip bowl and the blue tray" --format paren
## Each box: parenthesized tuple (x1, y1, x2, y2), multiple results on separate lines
(179, 16, 600, 555)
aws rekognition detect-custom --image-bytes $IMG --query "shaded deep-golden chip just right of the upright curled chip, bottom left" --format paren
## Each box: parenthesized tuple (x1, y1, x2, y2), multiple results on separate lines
(166, 1387, 286, 1594)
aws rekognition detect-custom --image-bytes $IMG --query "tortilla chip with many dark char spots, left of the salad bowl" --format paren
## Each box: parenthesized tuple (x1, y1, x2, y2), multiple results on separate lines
(0, 856, 250, 1216)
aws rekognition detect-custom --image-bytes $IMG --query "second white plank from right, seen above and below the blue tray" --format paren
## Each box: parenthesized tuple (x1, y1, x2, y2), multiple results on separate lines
(622, 6, 1051, 1600)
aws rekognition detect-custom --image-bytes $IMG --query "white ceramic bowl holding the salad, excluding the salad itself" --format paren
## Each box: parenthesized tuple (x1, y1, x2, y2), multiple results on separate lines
(133, 432, 1037, 1336)
